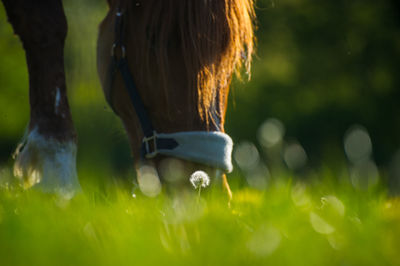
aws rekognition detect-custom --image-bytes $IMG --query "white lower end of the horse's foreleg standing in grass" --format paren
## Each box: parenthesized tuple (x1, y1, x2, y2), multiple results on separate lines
(14, 129, 81, 198)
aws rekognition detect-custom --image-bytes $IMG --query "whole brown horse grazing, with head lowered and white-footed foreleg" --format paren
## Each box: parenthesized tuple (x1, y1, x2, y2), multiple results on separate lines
(2, 0, 255, 197)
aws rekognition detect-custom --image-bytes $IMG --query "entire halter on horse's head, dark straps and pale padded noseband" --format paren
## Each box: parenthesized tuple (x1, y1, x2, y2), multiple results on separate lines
(106, 8, 233, 172)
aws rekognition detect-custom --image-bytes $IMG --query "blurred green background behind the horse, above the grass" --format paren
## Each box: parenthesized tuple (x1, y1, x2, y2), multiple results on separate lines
(0, 0, 400, 188)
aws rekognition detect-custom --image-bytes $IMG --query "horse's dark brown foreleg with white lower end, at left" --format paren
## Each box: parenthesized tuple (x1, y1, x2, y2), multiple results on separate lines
(3, 0, 79, 195)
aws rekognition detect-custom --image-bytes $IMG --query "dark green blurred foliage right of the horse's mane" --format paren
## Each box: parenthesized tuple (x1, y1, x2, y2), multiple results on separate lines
(227, 0, 400, 167)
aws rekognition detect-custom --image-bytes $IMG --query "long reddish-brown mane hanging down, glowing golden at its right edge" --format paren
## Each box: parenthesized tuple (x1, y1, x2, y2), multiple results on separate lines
(120, 0, 254, 123)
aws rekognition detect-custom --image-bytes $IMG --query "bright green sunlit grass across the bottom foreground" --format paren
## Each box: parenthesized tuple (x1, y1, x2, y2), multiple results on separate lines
(0, 170, 400, 265)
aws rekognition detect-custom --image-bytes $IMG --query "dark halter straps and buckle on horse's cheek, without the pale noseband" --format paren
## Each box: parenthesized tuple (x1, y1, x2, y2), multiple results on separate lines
(106, 8, 178, 159)
